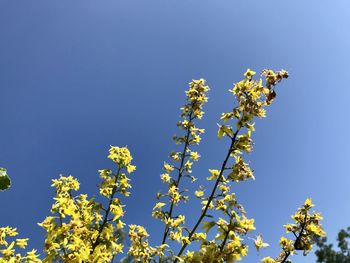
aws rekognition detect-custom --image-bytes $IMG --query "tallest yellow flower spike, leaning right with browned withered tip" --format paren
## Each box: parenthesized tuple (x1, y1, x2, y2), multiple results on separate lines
(167, 69, 288, 262)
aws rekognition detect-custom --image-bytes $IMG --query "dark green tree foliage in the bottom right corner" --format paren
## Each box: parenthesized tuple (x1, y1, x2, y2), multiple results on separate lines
(315, 227, 350, 263)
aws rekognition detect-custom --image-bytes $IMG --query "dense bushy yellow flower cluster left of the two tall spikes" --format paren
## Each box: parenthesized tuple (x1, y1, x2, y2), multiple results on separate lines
(39, 146, 136, 262)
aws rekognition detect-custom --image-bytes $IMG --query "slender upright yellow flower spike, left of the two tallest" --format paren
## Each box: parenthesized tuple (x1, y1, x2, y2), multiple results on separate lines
(152, 79, 209, 261)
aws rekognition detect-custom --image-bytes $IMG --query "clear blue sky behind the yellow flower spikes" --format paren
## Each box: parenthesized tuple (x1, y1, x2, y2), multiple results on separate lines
(0, 0, 350, 263)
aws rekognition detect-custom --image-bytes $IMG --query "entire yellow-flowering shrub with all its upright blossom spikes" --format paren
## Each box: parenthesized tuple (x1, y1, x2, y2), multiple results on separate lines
(0, 69, 325, 263)
